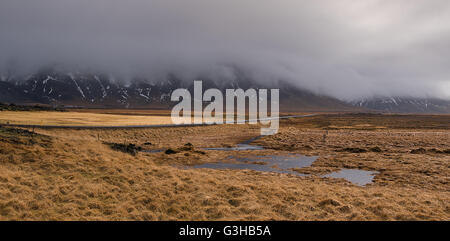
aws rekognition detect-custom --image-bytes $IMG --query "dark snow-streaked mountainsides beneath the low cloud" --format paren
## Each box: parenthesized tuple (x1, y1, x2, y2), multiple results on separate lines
(0, 70, 450, 113)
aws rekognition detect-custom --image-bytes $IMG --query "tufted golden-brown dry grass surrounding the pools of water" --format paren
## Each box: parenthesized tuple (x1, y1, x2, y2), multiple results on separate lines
(0, 112, 450, 220)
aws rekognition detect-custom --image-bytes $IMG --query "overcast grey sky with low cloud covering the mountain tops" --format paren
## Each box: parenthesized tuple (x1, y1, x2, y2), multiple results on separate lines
(0, 0, 450, 99)
